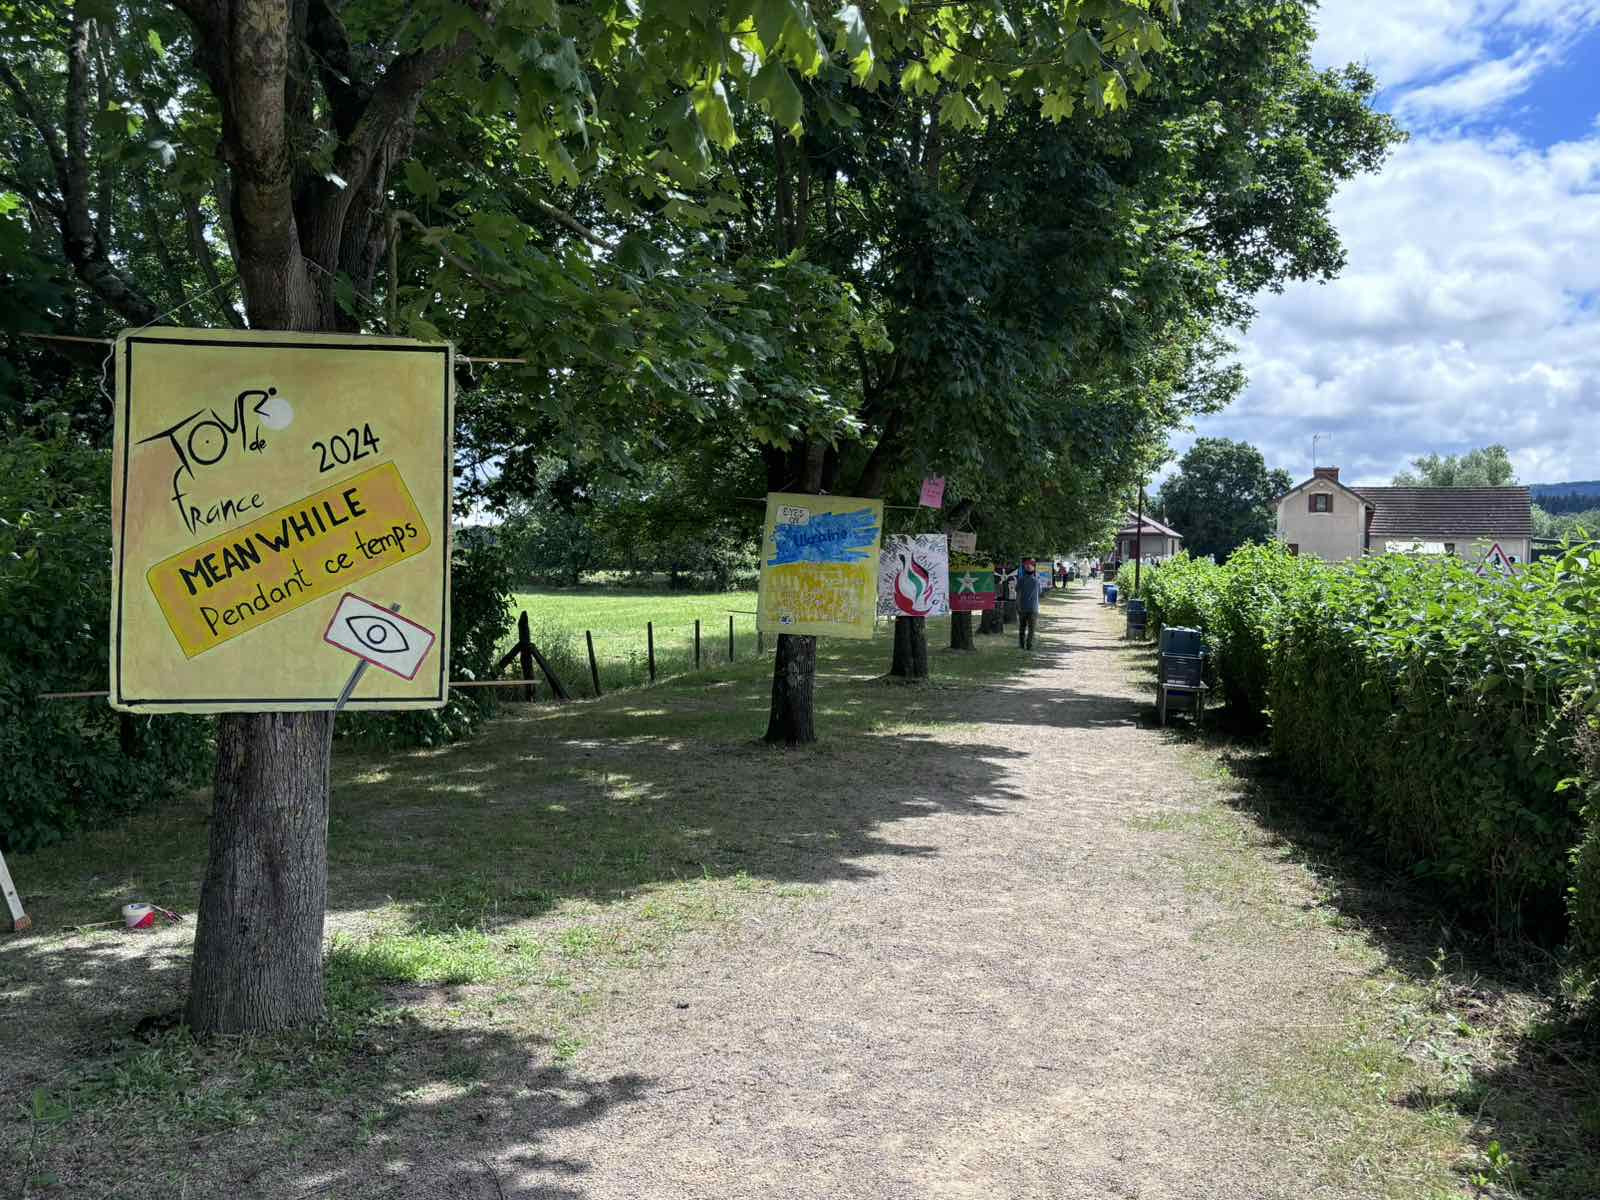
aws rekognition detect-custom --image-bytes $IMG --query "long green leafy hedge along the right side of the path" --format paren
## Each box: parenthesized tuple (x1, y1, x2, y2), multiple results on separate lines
(1149, 546, 1600, 963)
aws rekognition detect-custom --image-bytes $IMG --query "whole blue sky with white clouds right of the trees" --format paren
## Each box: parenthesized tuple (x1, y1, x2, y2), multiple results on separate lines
(1166, 0, 1600, 483)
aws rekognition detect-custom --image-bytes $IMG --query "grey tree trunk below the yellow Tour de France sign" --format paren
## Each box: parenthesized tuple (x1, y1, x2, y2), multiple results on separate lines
(189, 712, 333, 1035)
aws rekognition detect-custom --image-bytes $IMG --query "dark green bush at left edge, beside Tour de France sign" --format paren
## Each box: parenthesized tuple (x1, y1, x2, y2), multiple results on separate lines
(0, 426, 211, 850)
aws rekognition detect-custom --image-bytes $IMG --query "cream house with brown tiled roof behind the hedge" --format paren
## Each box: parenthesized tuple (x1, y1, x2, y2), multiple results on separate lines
(1278, 467, 1533, 563)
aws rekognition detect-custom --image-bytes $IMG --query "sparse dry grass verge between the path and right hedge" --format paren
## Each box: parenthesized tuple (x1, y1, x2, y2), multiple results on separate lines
(1134, 734, 1600, 1200)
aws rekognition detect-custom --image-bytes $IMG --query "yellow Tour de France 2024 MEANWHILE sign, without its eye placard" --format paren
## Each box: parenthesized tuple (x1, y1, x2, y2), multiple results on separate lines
(110, 328, 453, 712)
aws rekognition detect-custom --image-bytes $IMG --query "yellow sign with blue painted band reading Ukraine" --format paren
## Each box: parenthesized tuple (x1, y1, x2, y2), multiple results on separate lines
(755, 491, 883, 638)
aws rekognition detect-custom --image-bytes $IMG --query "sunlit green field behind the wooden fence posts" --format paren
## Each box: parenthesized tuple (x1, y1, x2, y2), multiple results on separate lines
(506, 587, 771, 696)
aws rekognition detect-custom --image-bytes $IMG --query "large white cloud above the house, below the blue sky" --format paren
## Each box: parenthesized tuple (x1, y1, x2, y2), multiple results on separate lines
(1174, 134, 1600, 483)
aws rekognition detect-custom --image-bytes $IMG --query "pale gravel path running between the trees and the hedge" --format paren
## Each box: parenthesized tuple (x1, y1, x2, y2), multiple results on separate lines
(473, 589, 1379, 1200)
